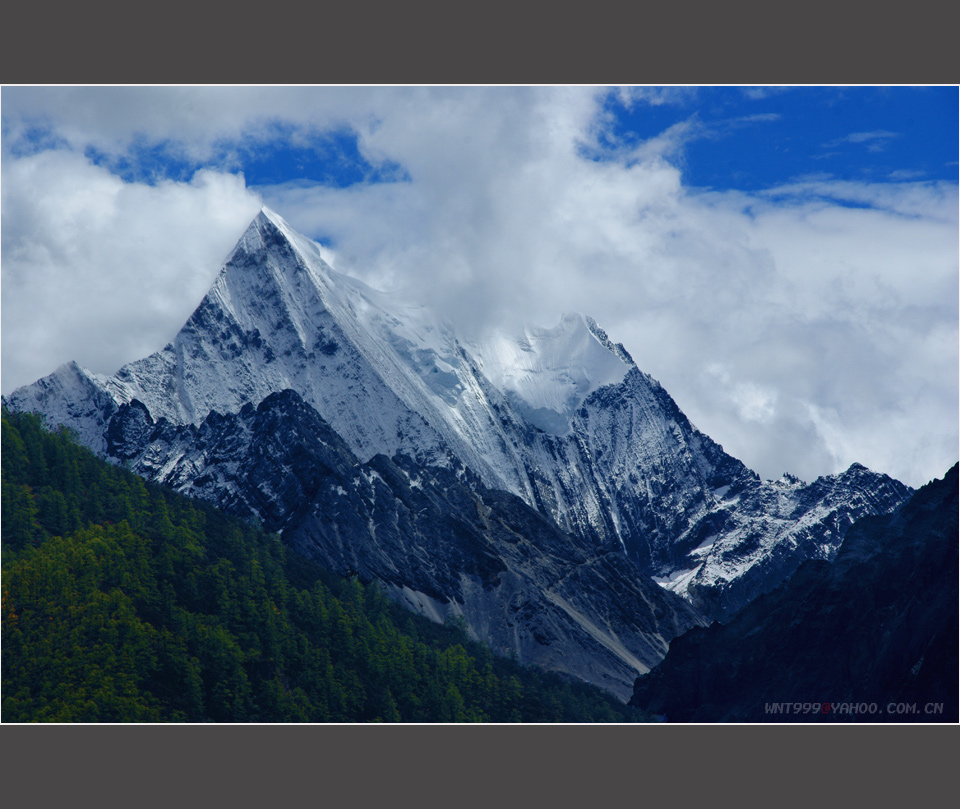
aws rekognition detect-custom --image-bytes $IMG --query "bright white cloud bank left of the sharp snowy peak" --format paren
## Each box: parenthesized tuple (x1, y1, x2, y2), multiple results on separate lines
(2, 151, 261, 392)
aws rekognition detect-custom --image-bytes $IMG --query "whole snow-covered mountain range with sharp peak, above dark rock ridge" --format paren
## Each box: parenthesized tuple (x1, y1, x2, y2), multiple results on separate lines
(8, 209, 909, 636)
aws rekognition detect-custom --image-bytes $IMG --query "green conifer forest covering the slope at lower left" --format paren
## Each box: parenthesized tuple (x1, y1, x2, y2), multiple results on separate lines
(2, 411, 642, 722)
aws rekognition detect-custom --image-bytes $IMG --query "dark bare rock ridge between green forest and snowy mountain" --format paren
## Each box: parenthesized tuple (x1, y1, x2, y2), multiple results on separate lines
(108, 390, 700, 700)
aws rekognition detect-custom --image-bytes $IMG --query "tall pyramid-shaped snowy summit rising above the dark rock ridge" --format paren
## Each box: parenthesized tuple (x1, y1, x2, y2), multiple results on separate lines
(102, 208, 454, 459)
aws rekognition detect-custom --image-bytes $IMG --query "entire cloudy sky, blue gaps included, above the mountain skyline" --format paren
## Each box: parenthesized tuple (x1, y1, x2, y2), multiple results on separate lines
(0, 86, 960, 485)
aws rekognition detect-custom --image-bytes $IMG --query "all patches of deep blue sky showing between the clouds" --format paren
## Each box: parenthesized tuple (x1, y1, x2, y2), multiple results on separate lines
(5, 86, 958, 199)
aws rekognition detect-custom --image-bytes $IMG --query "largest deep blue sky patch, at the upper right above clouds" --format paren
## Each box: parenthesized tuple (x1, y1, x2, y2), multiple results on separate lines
(592, 87, 957, 191)
